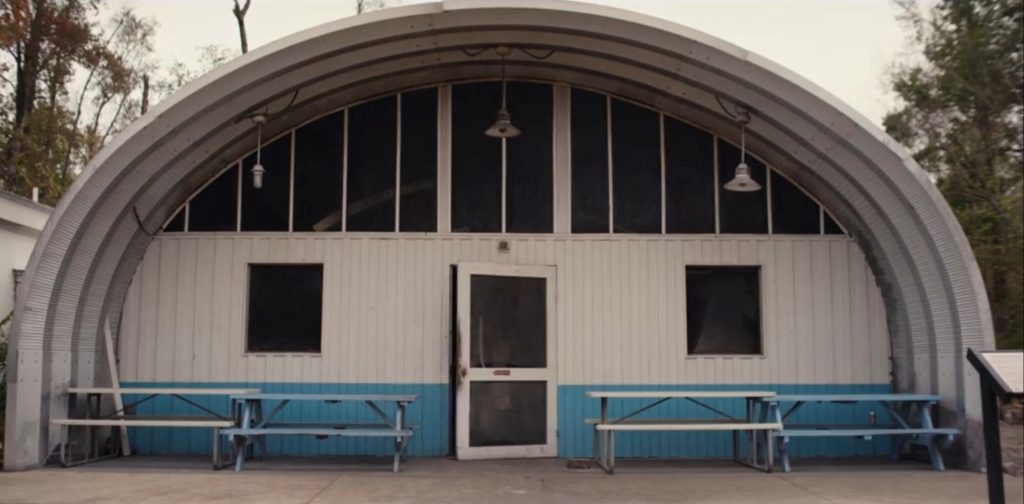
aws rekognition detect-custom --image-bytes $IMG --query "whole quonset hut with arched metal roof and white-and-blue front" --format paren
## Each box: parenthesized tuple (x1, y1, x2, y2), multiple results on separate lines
(5, 0, 993, 469)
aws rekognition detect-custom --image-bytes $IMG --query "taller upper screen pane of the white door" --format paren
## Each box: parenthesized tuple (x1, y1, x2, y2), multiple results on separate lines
(469, 275, 548, 368)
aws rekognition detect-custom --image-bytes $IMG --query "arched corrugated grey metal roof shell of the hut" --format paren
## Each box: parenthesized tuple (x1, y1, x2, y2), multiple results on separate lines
(5, 0, 993, 468)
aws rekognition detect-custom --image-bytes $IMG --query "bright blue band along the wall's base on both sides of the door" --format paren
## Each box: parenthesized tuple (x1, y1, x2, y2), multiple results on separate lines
(122, 382, 892, 458)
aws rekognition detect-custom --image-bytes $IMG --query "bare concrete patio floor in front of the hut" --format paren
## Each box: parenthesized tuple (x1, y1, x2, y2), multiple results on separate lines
(0, 457, 1024, 504)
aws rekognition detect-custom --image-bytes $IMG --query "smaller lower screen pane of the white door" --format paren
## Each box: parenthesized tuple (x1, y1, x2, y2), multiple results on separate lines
(469, 381, 548, 447)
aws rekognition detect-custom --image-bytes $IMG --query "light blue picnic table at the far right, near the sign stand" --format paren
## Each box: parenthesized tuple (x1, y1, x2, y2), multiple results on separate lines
(761, 393, 959, 472)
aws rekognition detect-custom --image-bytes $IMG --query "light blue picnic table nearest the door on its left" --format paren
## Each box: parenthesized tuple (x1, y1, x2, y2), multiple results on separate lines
(220, 393, 418, 472)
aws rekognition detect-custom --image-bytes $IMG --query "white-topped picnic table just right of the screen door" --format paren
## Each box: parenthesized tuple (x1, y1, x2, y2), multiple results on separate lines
(586, 390, 781, 474)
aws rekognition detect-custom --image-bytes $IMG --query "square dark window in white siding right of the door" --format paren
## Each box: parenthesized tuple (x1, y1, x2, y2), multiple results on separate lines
(686, 266, 762, 355)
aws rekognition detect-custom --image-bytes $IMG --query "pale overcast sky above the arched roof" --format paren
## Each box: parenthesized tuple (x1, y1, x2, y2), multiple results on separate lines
(110, 0, 931, 123)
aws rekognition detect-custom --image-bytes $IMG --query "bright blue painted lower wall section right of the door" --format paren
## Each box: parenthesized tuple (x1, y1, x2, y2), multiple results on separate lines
(558, 384, 892, 458)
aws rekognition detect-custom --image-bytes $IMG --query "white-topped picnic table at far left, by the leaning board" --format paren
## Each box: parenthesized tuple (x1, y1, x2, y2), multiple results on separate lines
(50, 387, 259, 468)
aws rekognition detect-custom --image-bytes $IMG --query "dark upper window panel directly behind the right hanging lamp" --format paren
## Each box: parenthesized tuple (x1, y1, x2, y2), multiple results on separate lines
(718, 139, 768, 234)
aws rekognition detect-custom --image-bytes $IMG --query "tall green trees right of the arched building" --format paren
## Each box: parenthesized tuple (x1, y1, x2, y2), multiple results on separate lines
(885, 0, 1024, 348)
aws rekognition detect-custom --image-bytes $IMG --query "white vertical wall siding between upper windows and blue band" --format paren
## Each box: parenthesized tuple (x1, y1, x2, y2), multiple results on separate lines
(119, 235, 890, 384)
